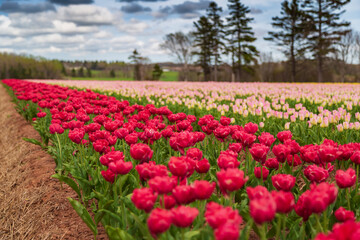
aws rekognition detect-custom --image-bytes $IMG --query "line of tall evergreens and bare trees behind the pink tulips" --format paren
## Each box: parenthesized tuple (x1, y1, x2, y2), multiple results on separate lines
(161, 0, 360, 82)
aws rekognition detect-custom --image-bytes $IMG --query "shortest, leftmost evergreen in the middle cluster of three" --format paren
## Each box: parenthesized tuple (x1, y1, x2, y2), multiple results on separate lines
(193, 16, 212, 81)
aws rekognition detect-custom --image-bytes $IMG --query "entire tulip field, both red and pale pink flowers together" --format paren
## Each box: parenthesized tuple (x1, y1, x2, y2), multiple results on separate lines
(2, 79, 360, 240)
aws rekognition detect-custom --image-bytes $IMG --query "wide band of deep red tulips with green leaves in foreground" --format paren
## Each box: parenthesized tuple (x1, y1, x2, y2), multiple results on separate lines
(3, 80, 360, 239)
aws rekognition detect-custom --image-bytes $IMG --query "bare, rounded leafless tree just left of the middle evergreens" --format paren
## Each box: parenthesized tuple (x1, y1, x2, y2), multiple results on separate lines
(160, 32, 194, 81)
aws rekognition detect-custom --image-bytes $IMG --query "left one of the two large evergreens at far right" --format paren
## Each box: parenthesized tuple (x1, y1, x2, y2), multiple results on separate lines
(265, 0, 305, 82)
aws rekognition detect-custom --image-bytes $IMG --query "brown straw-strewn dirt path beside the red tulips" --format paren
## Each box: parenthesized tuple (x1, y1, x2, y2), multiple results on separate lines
(0, 84, 105, 240)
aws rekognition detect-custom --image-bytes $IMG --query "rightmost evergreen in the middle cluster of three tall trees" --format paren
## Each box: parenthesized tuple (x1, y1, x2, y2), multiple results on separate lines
(226, 0, 258, 82)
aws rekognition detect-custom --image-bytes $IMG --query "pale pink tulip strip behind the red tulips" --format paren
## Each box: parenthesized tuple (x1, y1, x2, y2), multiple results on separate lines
(28, 80, 360, 144)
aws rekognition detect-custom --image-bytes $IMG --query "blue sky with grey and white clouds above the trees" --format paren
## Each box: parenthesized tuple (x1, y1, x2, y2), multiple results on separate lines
(0, 0, 360, 62)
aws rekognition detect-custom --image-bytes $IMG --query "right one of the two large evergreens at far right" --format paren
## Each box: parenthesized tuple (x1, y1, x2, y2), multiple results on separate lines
(304, 0, 350, 82)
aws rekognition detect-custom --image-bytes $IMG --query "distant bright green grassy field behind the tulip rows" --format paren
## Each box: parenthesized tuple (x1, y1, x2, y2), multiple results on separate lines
(68, 71, 179, 82)
